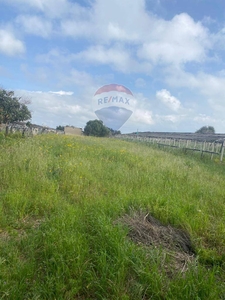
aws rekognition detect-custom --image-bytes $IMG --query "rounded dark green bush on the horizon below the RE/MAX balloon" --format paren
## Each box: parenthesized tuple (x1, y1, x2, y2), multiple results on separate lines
(84, 120, 110, 137)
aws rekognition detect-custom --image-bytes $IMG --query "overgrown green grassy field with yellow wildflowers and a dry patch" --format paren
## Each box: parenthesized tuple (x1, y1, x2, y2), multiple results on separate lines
(0, 133, 225, 300)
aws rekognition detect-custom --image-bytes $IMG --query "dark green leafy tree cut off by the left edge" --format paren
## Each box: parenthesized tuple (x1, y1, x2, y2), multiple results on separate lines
(0, 89, 31, 134)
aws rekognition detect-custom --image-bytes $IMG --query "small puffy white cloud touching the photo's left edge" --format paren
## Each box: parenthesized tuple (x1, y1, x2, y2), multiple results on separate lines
(0, 29, 26, 56)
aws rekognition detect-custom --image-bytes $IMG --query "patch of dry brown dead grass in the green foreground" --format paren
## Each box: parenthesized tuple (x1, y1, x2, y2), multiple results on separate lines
(119, 212, 195, 276)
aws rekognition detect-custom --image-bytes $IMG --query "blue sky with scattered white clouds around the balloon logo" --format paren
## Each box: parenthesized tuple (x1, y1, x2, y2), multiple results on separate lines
(0, 0, 225, 133)
